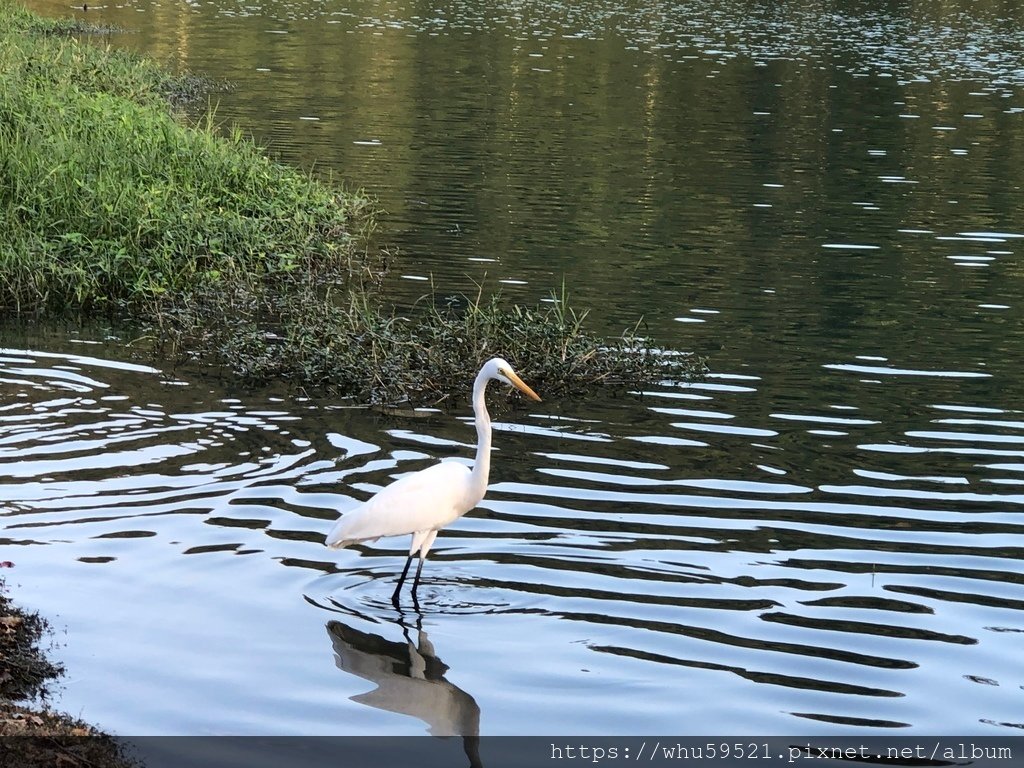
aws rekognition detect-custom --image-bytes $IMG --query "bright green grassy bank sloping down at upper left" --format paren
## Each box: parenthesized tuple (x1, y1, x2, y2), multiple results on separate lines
(0, 6, 373, 311)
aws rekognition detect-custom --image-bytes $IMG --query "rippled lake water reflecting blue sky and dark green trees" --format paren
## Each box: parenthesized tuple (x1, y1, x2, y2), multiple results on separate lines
(8, 0, 1024, 735)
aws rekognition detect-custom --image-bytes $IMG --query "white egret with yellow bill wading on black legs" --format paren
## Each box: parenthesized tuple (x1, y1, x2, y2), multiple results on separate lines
(326, 357, 541, 603)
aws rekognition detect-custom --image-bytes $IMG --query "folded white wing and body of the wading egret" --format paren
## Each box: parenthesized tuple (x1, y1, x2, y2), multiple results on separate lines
(326, 462, 471, 547)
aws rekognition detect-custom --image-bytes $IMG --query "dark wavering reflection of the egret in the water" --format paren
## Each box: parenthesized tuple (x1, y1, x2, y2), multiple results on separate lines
(327, 613, 482, 768)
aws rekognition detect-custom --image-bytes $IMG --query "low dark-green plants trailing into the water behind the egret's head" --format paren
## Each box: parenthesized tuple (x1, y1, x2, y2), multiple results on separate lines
(159, 285, 705, 404)
